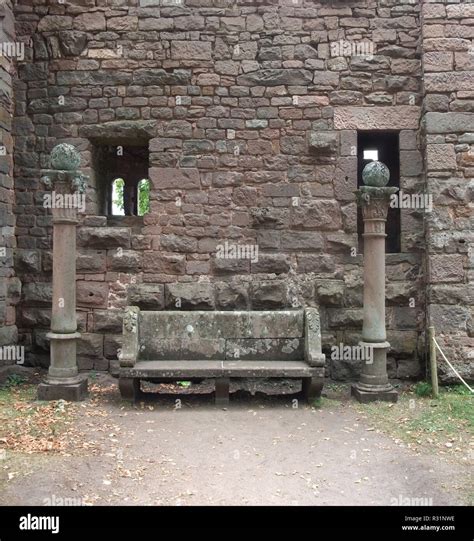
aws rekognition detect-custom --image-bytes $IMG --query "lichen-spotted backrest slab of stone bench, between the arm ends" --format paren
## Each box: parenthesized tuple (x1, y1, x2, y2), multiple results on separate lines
(140, 310, 304, 360)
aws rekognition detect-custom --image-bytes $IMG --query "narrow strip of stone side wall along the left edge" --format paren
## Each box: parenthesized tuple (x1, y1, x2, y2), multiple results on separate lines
(0, 1, 20, 366)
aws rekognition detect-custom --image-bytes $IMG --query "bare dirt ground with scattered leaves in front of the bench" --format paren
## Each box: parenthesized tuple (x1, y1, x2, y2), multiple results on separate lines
(0, 376, 472, 505)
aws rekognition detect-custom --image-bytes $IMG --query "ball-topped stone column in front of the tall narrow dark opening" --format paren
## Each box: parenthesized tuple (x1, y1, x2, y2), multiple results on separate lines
(352, 161, 398, 402)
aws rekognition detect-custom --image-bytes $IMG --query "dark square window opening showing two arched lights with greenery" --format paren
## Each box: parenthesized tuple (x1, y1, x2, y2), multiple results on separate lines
(94, 145, 150, 216)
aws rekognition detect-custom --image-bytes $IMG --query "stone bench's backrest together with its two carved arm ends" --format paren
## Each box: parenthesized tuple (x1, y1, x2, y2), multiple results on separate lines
(121, 306, 324, 366)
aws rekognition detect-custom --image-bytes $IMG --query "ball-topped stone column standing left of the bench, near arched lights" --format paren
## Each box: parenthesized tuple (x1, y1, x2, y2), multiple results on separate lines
(38, 143, 87, 401)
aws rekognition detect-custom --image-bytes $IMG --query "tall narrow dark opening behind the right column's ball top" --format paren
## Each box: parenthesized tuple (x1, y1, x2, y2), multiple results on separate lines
(357, 131, 401, 254)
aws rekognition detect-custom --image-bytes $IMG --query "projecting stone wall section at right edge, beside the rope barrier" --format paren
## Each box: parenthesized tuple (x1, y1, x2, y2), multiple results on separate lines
(423, 0, 474, 380)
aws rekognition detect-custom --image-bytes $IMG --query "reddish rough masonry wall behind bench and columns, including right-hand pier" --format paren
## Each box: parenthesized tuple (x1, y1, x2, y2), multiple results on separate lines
(5, 0, 474, 379)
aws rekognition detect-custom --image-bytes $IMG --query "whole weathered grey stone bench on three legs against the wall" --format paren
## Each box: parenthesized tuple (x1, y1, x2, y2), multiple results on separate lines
(119, 306, 326, 405)
